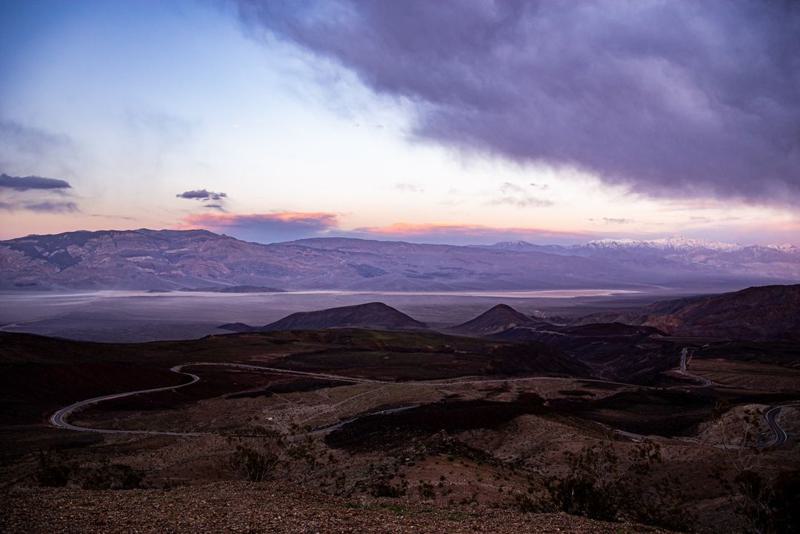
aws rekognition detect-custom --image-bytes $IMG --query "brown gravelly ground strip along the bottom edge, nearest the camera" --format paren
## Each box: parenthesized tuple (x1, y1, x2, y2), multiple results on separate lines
(0, 483, 662, 534)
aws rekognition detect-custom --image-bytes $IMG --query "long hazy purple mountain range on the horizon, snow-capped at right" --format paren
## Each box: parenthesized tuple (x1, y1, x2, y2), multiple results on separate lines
(0, 229, 800, 291)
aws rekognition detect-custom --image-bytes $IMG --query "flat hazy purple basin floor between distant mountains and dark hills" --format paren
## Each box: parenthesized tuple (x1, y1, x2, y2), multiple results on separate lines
(0, 289, 655, 341)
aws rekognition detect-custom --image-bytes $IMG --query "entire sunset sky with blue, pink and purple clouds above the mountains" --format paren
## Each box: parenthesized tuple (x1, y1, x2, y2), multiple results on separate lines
(0, 0, 800, 244)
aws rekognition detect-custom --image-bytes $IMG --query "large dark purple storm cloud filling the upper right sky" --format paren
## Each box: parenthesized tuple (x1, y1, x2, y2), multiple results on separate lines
(238, 0, 800, 203)
